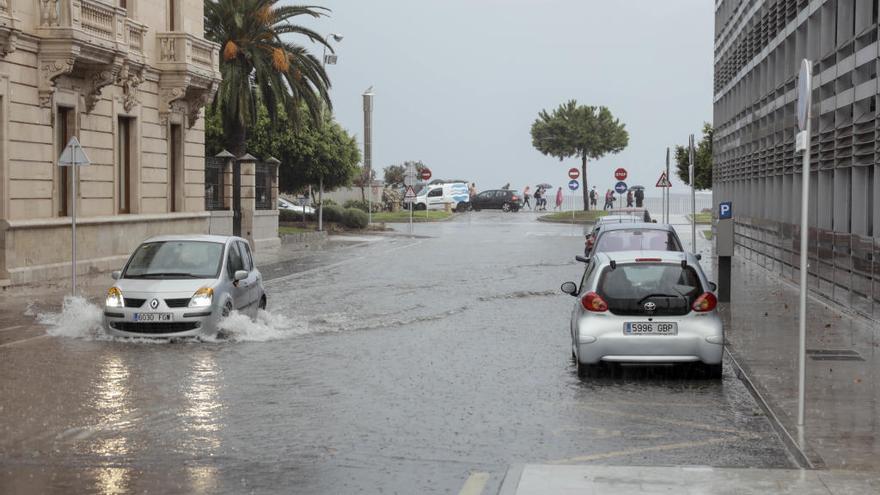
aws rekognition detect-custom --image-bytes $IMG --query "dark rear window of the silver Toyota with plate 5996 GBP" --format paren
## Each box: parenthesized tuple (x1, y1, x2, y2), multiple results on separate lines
(596, 263, 703, 309)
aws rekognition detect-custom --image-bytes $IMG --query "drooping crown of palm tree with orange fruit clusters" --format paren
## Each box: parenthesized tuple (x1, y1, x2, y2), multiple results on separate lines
(205, 0, 333, 156)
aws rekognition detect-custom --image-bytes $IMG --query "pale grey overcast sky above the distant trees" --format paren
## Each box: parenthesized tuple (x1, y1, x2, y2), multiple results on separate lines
(295, 0, 714, 195)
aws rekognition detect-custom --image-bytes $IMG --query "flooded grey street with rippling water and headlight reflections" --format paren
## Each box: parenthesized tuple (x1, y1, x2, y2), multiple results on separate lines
(0, 211, 793, 494)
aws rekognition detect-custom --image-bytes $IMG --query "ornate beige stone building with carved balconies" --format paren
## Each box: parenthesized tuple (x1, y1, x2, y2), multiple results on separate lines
(0, 0, 230, 285)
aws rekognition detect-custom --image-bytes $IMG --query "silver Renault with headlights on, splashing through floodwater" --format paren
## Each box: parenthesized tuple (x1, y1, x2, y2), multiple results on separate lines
(104, 235, 266, 338)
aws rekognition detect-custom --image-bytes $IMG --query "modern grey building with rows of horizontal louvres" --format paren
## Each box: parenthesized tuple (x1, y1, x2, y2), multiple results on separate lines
(713, 0, 880, 319)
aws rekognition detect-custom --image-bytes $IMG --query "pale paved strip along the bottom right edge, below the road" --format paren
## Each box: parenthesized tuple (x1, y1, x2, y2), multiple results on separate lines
(498, 464, 880, 495)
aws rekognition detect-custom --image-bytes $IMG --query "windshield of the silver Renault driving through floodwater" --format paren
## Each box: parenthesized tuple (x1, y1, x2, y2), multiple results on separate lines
(122, 241, 223, 278)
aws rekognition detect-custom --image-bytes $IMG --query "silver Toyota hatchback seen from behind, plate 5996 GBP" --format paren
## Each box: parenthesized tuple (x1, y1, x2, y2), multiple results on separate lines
(562, 251, 724, 378)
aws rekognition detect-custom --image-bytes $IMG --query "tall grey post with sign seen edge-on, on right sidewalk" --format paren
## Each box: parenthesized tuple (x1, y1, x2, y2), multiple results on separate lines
(795, 59, 813, 428)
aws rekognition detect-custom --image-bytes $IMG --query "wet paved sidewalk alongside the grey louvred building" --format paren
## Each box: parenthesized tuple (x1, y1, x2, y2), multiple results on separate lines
(721, 257, 880, 472)
